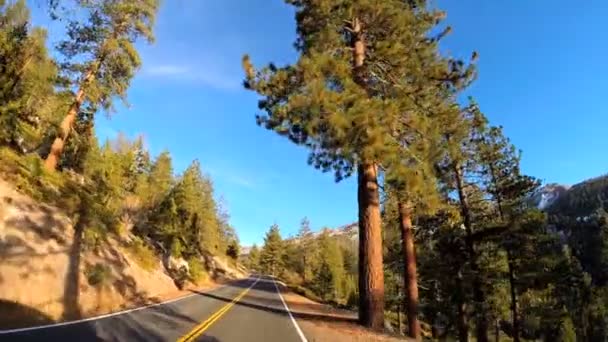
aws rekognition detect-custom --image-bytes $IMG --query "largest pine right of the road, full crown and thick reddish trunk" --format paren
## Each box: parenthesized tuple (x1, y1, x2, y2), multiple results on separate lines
(244, 0, 476, 329)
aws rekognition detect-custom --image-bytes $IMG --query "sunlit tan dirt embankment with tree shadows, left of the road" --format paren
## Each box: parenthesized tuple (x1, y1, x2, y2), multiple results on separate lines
(0, 180, 245, 329)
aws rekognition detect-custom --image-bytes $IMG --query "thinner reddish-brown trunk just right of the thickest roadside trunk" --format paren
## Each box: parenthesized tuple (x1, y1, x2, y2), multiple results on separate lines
(399, 201, 420, 340)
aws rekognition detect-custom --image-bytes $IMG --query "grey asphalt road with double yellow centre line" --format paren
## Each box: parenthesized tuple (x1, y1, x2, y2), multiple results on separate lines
(0, 277, 306, 342)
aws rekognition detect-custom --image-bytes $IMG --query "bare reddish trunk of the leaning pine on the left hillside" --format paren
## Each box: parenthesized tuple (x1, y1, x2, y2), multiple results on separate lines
(44, 63, 99, 171)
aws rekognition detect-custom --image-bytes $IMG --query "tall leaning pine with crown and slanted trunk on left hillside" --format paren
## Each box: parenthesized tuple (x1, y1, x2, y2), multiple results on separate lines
(45, 0, 158, 170)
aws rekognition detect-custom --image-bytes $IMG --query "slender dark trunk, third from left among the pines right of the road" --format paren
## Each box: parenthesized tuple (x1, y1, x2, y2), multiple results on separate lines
(453, 163, 488, 342)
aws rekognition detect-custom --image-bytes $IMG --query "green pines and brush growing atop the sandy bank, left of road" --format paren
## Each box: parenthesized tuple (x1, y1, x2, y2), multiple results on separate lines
(0, 0, 239, 292)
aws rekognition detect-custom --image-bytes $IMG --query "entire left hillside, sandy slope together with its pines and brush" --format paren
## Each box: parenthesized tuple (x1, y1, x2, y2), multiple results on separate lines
(0, 0, 243, 325)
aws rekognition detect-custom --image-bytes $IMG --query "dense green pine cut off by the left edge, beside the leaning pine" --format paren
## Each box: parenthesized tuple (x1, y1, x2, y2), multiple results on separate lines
(0, 0, 60, 153)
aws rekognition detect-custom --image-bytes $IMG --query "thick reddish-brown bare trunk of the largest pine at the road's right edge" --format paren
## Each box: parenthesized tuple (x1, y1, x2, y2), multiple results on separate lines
(357, 163, 384, 330)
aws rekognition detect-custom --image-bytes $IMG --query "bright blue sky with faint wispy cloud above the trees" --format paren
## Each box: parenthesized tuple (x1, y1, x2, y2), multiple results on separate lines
(29, 0, 608, 245)
